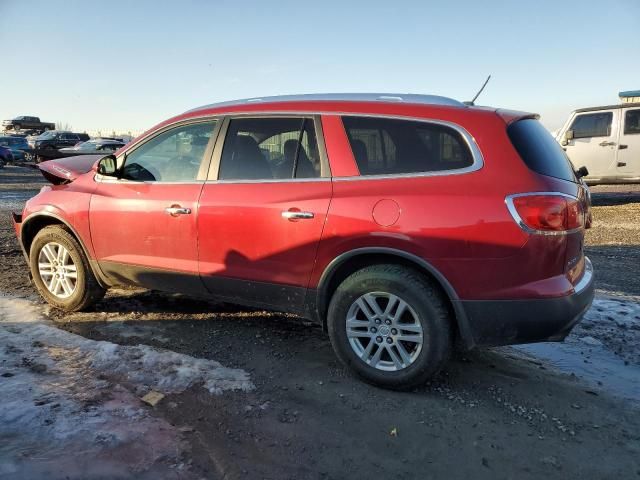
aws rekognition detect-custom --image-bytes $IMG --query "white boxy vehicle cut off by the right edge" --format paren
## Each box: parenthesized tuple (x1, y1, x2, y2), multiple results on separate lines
(556, 98, 640, 185)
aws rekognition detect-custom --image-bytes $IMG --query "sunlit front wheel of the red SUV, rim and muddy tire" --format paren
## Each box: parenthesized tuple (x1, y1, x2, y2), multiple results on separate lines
(29, 225, 105, 312)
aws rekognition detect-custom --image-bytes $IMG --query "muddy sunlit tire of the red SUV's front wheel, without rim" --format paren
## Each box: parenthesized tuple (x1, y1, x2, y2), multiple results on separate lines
(29, 225, 106, 312)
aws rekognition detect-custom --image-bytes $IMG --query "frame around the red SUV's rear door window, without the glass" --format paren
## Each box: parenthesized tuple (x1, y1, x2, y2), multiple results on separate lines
(206, 112, 331, 184)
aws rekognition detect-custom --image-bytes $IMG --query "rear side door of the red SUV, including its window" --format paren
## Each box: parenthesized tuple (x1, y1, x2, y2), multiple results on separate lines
(198, 115, 332, 311)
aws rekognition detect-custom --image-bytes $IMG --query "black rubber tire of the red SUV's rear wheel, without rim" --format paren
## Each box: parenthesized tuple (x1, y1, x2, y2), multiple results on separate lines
(327, 265, 454, 390)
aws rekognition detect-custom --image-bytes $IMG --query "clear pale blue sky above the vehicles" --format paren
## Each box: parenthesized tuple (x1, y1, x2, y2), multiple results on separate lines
(0, 0, 640, 131)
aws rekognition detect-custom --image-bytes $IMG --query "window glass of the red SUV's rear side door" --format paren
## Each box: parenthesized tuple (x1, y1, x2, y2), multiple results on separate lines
(218, 117, 321, 180)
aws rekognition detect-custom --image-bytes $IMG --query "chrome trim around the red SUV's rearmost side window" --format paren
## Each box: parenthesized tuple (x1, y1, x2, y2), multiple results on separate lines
(333, 113, 484, 181)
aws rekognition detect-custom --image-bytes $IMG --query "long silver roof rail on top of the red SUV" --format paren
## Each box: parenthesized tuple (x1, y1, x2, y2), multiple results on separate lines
(187, 93, 466, 113)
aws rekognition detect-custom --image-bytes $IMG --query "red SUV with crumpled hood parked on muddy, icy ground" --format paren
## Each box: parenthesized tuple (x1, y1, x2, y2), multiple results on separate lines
(14, 94, 593, 388)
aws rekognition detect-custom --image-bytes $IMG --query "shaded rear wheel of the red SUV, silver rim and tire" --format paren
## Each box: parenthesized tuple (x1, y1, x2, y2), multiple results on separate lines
(327, 265, 452, 389)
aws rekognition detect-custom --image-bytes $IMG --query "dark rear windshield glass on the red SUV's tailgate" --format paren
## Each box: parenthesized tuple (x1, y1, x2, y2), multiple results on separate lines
(507, 119, 576, 182)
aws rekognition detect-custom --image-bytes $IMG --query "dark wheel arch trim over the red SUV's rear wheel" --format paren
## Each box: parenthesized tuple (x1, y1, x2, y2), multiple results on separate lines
(315, 247, 473, 348)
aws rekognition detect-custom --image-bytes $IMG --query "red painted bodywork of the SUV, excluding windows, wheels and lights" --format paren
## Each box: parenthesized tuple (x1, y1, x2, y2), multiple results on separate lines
(17, 98, 584, 308)
